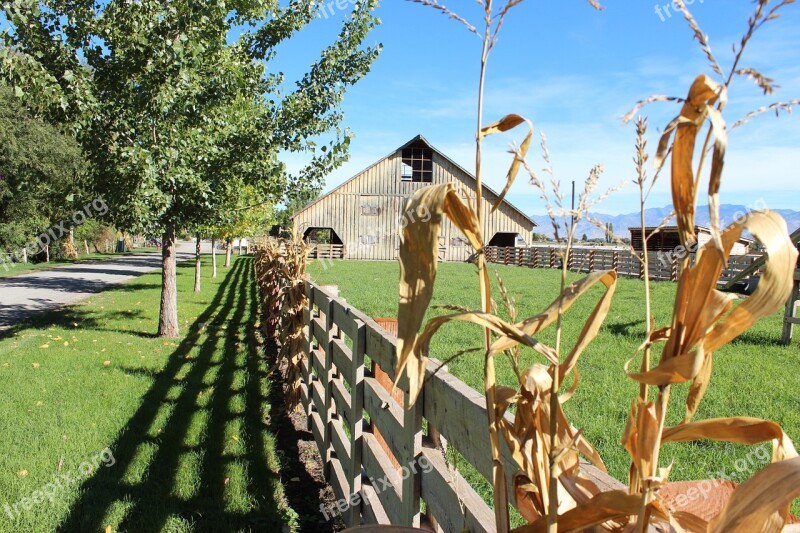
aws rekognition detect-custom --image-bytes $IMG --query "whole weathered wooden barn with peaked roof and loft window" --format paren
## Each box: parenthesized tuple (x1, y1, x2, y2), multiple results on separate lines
(293, 135, 536, 261)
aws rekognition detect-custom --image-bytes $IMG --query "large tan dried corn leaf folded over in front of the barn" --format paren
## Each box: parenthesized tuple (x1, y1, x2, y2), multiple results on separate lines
(395, 184, 483, 405)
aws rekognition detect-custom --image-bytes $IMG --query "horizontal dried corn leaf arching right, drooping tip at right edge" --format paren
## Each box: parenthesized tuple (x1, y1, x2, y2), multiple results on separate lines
(662, 416, 797, 462)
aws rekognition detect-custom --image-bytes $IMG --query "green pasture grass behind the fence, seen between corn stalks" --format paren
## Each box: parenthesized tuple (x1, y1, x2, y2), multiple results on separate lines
(309, 261, 800, 513)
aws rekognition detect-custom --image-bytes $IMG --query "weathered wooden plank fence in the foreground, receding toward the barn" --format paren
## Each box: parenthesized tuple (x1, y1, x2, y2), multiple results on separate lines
(302, 282, 622, 532)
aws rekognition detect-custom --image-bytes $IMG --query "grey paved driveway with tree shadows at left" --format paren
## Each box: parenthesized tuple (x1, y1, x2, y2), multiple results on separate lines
(0, 243, 206, 331)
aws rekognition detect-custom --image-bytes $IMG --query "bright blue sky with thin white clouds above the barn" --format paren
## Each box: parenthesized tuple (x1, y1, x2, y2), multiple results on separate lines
(277, 0, 800, 214)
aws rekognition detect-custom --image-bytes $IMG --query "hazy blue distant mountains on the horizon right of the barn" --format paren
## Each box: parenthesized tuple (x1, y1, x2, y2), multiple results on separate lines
(532, 204, 800, 239)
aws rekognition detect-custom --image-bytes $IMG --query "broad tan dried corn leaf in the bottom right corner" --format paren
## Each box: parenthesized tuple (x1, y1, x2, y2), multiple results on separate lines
(708, 457, 800, 533)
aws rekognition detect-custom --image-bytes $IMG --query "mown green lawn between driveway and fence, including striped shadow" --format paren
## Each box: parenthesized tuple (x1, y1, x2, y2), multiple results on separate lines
(0, 257, 297, 532)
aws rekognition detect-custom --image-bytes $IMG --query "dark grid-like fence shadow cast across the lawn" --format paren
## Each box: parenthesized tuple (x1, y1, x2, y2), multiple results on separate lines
(59, 259, 287, 532)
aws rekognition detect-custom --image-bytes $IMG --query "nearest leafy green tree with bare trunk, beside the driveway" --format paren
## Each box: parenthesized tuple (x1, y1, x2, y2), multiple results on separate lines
(0, 0, 379, 337)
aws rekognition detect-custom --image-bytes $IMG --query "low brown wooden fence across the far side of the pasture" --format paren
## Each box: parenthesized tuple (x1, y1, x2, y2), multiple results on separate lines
(486, 246, 761, 283)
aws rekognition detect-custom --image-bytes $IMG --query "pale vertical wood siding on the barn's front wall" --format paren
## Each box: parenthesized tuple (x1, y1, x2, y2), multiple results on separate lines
(295, 152, 532, 261)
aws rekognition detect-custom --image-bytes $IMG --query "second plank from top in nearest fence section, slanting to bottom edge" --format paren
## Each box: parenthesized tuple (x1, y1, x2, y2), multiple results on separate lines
(419, 448, 497, 533)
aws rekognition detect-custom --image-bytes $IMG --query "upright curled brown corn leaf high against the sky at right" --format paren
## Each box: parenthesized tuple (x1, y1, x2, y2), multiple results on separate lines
(672, 74, 721, 246)
